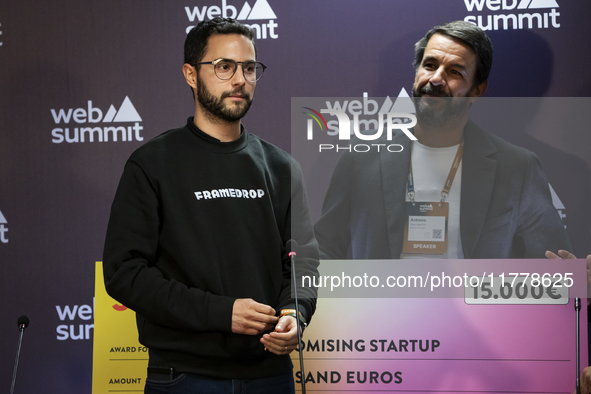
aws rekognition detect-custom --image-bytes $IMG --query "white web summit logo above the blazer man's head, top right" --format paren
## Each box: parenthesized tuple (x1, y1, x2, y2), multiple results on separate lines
(464, 0, 560, 30)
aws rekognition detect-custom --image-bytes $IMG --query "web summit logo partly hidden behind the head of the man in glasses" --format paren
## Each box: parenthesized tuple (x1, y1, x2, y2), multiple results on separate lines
(185, 0, 279, 40)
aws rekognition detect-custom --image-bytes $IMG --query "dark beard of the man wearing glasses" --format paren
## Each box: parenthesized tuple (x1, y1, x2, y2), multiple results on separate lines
(197, 74, 252, 123)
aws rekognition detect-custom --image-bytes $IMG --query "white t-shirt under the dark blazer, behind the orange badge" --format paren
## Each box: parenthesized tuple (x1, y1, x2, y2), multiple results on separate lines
(400, 141, 464, 259)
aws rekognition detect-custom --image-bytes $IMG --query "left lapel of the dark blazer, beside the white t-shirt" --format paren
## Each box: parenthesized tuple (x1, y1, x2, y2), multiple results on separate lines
(380, 132, 411, 259)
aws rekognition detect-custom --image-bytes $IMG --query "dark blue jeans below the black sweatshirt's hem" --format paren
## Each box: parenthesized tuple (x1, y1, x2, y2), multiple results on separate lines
(144, 372, 295, 394)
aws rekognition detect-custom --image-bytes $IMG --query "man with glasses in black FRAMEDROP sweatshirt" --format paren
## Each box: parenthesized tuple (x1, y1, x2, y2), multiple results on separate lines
(104, 18, 318, 393)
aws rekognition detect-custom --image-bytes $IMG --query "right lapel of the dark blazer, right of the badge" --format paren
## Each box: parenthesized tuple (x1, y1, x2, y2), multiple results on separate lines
(460, 121, 497, 259)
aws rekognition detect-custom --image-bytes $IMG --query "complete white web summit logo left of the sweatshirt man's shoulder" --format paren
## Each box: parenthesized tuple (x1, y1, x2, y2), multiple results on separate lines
(51, 96, 144, 144)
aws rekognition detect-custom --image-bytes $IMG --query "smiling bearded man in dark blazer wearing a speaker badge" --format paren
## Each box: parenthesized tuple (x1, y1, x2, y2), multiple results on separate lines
(315, 21, 571, 259)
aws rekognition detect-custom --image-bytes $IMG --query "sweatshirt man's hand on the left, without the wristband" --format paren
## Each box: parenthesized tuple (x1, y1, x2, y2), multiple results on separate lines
(232, 298, 279, 335)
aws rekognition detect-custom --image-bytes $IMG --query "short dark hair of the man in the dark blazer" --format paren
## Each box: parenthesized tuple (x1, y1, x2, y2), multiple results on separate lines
(413, 21, 492, 86)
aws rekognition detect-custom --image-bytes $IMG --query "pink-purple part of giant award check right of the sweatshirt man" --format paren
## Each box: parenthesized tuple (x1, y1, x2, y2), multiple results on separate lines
(292, 260, 587, 393)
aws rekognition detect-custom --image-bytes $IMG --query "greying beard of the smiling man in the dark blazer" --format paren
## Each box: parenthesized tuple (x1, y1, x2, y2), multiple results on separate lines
(412, 83, 470, 127)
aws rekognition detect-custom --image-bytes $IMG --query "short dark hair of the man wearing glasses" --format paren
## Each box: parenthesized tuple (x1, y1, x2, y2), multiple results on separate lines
(185, 17, 256, 69)
